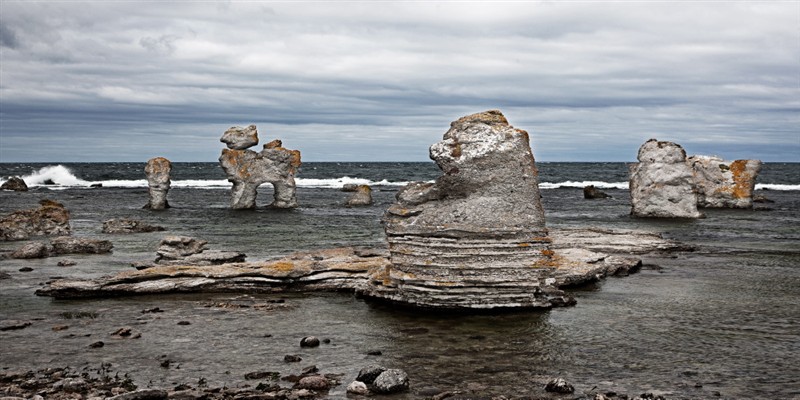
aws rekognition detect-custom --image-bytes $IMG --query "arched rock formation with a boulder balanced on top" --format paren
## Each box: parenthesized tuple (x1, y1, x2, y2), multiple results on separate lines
(219, 125, 300, 210)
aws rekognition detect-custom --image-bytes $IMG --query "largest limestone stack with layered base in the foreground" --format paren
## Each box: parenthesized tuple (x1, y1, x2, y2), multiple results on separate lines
(372, 110, 554, 309)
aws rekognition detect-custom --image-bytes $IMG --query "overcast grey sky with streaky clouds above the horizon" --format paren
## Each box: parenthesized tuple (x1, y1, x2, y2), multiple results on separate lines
(0, 0, 800, 162)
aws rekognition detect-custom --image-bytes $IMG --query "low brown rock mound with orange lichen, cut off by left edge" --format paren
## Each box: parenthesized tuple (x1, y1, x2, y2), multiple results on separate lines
(0, 200, 70, 240)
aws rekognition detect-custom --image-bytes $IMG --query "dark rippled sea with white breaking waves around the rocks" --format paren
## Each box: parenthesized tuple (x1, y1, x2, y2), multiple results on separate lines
(0, 162, 800, 399)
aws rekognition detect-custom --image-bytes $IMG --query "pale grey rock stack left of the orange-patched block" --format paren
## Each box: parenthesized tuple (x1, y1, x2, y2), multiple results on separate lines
(630, 139, 703, 218)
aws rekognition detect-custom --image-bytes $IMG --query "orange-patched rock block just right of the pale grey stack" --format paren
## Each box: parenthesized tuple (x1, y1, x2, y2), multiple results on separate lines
(687, 156, 761, 208)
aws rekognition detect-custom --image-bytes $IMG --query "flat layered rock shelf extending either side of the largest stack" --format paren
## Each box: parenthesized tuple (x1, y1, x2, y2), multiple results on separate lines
(36, 229, 687, 300)
